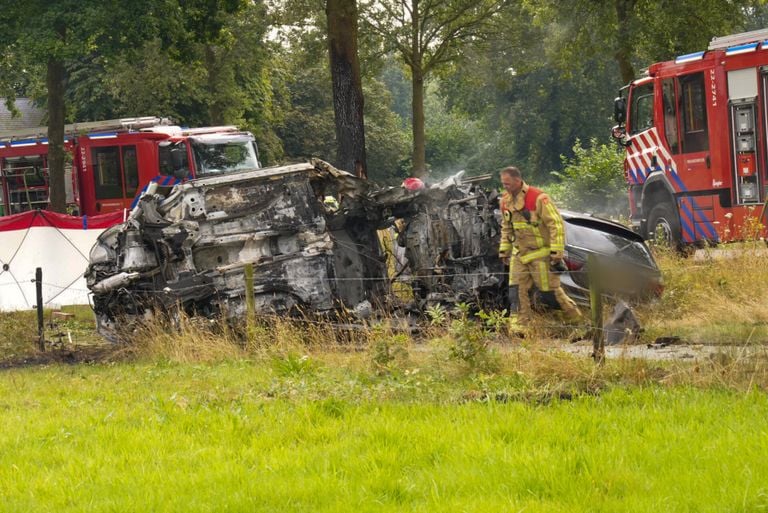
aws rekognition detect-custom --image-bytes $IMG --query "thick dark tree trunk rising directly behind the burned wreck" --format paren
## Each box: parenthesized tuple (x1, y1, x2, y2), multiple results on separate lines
(325, 0, 368, 178)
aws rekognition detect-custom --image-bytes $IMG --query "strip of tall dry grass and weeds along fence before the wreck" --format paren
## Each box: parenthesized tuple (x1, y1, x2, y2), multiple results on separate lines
(115, 308, 768, 392)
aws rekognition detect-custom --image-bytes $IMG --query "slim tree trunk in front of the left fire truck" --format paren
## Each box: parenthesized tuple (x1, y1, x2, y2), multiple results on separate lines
(45, 57, 67, 213)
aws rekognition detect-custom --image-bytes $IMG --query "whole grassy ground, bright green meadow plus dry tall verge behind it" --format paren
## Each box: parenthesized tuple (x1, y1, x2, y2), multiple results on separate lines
(0, 246, 768, 512)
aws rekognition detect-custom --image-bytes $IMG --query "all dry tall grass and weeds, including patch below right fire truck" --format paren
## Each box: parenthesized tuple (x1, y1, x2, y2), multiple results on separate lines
(0, 240, 768, 388)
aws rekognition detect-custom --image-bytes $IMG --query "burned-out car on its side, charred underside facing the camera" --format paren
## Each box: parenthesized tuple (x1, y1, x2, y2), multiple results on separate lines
(86, 160, 387, 338)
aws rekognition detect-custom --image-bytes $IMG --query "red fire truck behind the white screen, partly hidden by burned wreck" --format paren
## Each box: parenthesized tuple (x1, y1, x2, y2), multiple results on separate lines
(0, 117, 260, 216)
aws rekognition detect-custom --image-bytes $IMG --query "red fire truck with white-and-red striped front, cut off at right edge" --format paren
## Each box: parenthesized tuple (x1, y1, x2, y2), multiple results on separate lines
(613, 29, 768, 244)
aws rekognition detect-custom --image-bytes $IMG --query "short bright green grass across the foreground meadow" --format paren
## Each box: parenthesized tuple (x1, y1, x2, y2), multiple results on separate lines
(0, 359, 768, 512)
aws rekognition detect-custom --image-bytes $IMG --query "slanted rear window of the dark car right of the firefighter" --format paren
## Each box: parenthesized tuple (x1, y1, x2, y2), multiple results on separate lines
(565, 221, 655, 267)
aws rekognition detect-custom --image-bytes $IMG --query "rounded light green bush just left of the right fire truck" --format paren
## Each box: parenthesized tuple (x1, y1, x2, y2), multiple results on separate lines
(549, 139, 627, 217)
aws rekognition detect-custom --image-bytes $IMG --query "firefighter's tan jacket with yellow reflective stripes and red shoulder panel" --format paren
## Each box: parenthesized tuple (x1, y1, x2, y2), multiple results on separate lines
(499, 183, 565, 264)
